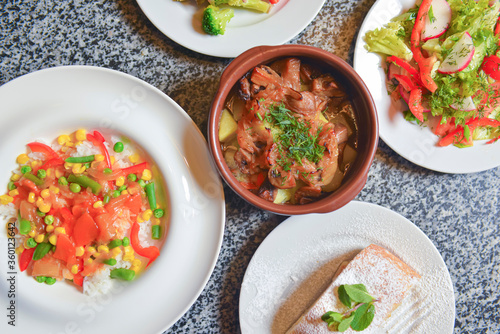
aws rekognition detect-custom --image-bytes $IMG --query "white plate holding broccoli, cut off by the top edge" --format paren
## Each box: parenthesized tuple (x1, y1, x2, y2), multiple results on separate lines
(137, 0, 325, 58)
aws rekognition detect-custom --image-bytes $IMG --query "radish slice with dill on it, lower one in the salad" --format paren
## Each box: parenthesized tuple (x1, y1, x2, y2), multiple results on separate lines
(438, 32, 475, 74)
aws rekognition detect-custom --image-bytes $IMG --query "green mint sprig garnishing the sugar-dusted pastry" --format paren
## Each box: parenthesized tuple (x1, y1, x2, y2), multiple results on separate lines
(321, 284, 377, 332)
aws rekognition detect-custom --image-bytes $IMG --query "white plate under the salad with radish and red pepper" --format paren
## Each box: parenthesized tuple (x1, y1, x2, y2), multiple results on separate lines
(354, 0, 500, 173)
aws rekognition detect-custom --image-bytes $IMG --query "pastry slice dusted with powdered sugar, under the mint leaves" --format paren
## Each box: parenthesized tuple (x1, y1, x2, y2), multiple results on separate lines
(286, 244, 420, 334)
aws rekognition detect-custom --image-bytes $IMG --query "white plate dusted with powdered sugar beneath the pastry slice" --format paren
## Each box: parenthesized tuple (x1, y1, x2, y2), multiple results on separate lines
(239, 201, 455, 334)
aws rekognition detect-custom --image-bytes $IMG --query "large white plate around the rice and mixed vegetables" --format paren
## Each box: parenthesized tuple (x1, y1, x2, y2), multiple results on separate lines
(0, 66, 225, 333)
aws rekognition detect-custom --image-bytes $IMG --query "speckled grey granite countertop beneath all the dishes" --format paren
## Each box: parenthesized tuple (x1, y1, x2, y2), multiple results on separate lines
(0, 0, 500, 333)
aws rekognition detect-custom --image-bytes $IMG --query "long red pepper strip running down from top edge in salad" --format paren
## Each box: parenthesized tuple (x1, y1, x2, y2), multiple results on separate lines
(410, 0, 437, 93)
